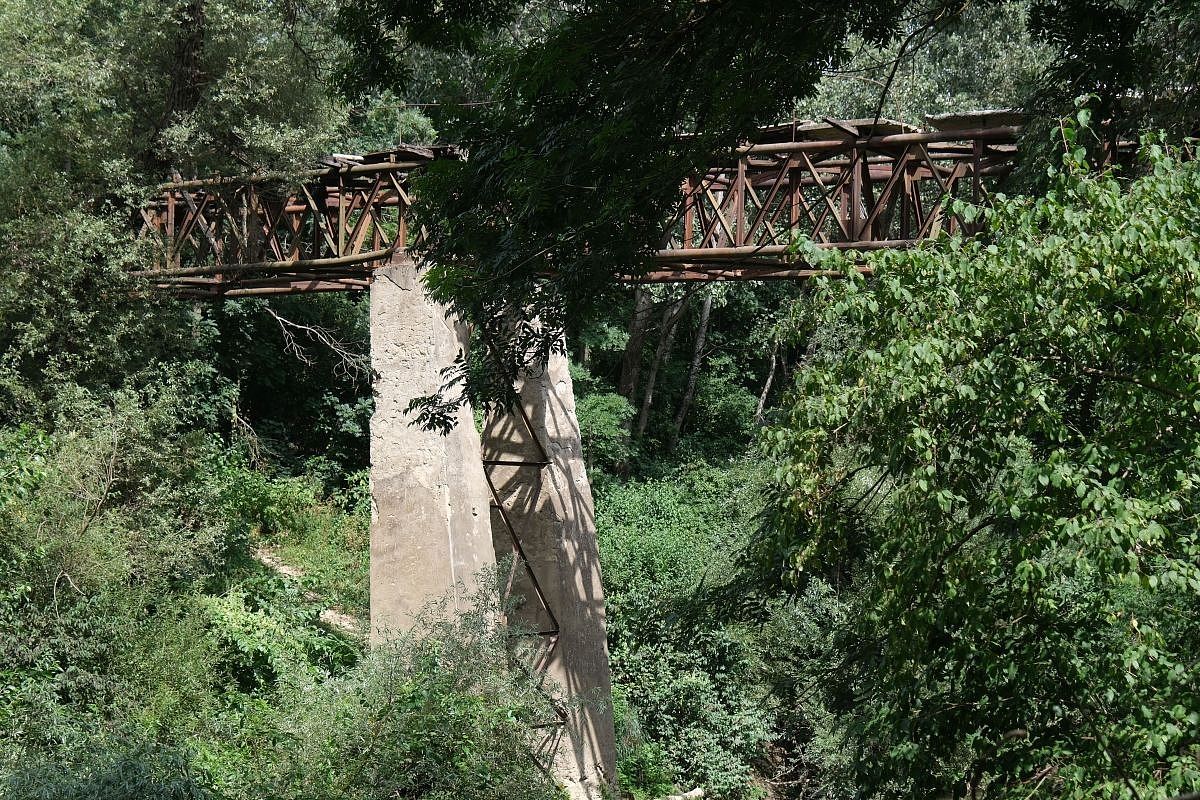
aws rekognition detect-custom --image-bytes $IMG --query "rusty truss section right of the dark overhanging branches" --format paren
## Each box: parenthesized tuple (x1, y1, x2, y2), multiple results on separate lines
(643, 122, 1020, 281)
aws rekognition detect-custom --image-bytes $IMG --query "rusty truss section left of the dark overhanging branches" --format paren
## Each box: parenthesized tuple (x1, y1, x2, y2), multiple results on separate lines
(133, 148, 438, 296)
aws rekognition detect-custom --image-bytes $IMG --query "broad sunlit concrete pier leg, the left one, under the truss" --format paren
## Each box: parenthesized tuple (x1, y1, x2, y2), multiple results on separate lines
(371, 254, 496, 643)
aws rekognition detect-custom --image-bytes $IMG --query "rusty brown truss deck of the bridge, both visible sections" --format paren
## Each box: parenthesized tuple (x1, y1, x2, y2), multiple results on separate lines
(139, 112, 1020, 297)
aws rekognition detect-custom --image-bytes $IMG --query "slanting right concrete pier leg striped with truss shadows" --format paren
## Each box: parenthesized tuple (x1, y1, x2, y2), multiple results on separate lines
(484, 355, 616, 800)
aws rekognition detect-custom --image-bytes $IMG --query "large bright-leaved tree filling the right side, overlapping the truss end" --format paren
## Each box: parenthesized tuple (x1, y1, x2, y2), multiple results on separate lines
(755, 134, 1200, 798)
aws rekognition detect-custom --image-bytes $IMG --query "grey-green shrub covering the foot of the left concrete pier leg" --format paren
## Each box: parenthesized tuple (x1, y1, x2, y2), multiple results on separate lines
(258, 594, 562, 800)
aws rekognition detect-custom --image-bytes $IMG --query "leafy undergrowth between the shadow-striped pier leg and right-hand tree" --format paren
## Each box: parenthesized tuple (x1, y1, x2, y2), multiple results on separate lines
(596, 463, 773, 798)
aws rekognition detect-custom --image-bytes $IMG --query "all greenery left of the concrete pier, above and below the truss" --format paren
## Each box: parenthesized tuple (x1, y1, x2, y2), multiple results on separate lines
(0, 0, 558, 800)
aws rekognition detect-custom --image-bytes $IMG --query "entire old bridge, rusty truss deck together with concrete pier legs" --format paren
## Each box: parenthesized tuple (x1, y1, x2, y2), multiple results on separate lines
(129, 112, 1019, 800)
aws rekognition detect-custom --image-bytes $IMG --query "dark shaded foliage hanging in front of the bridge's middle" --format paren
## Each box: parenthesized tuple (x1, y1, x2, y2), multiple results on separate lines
(341, 0, 905, 420)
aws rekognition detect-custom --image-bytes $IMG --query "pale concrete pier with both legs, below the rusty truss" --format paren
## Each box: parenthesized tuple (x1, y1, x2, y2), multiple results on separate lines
(371, 261, 616, 800)
